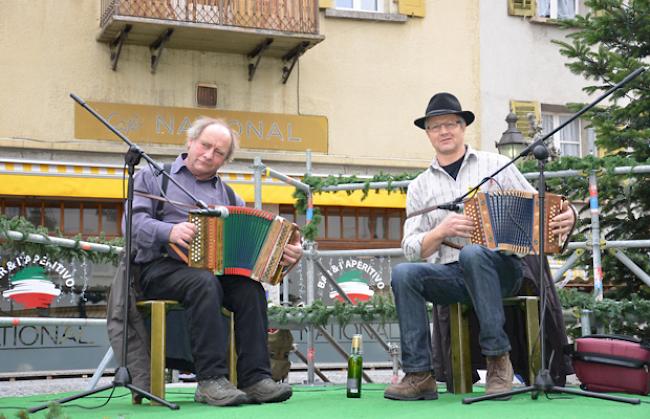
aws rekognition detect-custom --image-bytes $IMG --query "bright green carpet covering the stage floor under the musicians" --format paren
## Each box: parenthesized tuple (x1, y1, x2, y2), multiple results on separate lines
(0, 382, 650, 419)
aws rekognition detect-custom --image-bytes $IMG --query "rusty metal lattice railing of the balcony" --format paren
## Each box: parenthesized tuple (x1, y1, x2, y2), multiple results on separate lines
(100, 0, 318, 34)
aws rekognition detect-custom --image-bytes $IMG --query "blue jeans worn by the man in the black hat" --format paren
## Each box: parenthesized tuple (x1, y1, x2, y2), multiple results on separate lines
(391, 245, 522, 372)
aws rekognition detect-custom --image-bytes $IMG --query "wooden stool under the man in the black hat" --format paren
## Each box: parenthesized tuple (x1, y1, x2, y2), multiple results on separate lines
(448, 296, 542, 394)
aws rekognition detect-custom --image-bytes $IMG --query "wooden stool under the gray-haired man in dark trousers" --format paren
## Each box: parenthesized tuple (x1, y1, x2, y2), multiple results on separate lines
(137, 300, 237, 398)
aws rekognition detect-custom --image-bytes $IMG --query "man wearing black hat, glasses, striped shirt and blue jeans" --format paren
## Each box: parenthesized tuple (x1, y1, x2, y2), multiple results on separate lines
(384, 93, 575, 400)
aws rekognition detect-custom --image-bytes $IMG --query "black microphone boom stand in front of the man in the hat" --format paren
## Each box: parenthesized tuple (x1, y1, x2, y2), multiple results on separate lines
(454, 67, 645, 404)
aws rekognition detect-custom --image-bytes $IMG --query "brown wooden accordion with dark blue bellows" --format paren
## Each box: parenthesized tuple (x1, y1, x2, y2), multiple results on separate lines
(465, 190, 564, 256)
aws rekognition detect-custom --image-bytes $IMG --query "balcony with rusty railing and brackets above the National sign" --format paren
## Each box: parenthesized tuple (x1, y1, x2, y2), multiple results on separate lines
(97, 0, 325, 77)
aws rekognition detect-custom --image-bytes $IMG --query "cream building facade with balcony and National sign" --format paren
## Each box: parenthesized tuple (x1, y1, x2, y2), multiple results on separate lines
(0, 0, 480, 249)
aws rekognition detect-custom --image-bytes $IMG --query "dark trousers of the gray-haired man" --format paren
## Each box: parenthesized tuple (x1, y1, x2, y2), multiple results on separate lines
(140, 257, 271, 388)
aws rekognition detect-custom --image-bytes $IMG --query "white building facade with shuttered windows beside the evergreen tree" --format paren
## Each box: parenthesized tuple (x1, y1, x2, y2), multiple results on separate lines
(480, 0, 593, 156)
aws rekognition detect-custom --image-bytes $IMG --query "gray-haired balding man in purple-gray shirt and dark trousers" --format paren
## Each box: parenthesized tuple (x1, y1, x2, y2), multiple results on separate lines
(133, 118, 302, 406)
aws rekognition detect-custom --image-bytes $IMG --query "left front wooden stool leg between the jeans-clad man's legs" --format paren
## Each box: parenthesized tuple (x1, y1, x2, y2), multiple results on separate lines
(448, 304, 473, 394)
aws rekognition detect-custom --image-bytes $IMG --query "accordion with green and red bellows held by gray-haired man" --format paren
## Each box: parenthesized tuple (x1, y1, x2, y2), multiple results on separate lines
(188, 207, 297, 285)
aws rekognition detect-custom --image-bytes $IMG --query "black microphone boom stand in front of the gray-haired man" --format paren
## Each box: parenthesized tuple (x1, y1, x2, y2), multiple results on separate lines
(28, 93, 228, 413)
